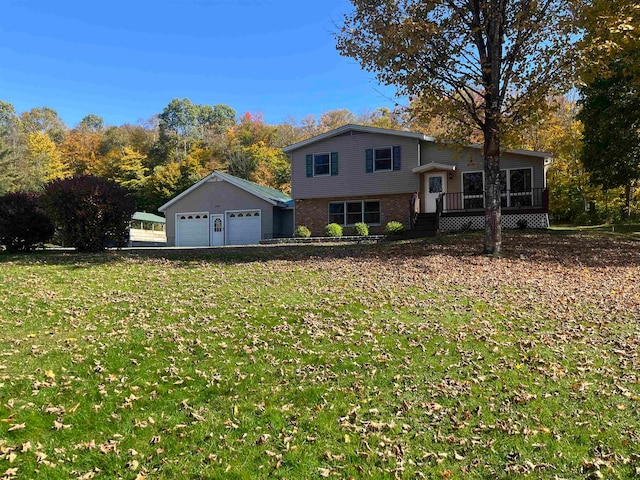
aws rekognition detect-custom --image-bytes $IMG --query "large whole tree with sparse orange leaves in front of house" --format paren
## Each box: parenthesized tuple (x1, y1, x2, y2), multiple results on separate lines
(336, 0, 574, 253)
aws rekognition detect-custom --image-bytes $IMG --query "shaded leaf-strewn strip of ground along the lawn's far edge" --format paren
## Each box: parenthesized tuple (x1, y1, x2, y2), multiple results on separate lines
(0, 230, 640, 269)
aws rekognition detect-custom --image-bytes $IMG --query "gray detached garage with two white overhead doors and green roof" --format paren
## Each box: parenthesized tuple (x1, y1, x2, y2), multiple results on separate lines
(159, 172, 293, 247)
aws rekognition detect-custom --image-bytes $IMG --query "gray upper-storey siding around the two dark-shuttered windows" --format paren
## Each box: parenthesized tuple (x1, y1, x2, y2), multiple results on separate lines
(291, 131, 420, 199)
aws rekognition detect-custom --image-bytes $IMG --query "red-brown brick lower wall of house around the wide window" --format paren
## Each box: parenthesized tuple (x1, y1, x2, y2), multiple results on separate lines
(295, 192, 413, 237)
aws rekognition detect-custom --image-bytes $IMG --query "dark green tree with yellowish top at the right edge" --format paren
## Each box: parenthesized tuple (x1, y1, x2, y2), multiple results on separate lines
(578, 0, 640, 215)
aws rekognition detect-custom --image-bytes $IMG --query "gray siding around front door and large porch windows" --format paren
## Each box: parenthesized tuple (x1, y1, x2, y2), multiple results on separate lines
(421, 143, 545, 193)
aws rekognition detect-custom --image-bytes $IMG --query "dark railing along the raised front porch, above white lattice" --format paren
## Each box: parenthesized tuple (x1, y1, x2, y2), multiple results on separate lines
(441, 188, 549, 212)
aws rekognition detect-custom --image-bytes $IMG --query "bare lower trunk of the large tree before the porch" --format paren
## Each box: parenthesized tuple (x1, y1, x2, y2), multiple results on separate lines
(484, 111, 502, 254)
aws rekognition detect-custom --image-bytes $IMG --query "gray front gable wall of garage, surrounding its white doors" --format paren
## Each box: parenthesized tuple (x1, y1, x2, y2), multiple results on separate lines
(165, 179, 273, 246)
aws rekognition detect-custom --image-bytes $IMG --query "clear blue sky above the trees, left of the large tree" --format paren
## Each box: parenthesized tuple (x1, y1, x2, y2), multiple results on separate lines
(0, 0, 395, 127)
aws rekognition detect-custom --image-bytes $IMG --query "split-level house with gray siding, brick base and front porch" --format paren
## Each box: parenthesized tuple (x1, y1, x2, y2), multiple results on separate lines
(284, 125, 551, 235)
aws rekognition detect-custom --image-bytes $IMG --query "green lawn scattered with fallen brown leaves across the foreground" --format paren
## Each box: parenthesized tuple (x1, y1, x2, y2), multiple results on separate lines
(0, 233, 640, 479)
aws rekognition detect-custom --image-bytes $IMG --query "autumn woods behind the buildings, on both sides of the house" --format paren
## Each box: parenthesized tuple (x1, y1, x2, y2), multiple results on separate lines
(0, 96, 638, 227)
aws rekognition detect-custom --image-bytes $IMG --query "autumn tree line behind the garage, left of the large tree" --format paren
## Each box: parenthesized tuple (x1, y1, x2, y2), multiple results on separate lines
(0, 98, 403, 212)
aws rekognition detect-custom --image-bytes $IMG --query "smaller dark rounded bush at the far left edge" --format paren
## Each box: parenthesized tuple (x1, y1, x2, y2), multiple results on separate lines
(0, 192, 54, 252)
